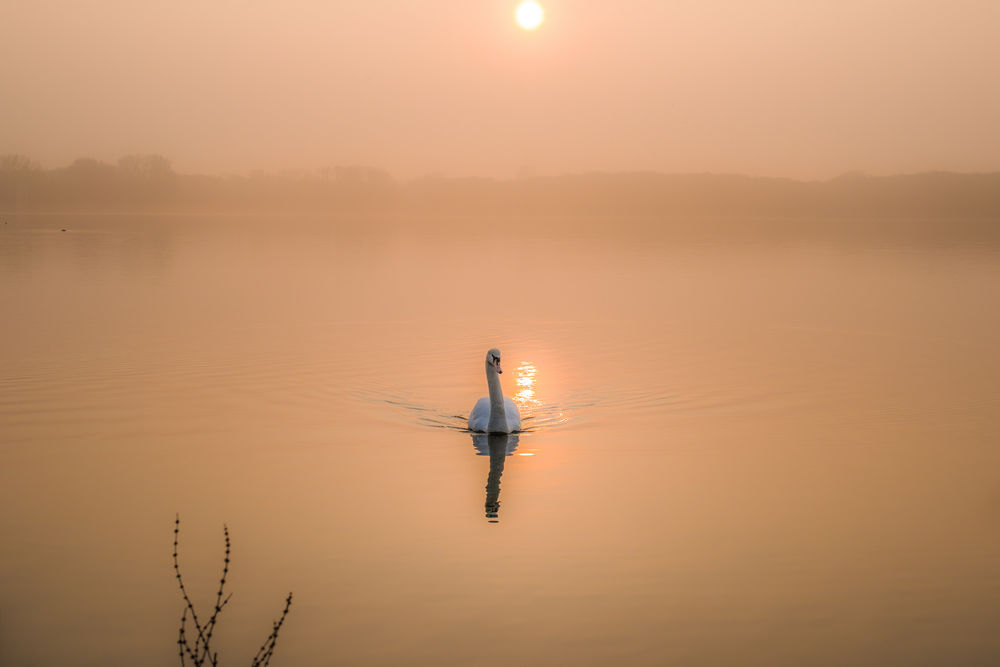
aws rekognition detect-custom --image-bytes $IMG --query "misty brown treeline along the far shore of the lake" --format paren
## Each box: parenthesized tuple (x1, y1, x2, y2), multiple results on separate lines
(0, 155, 1000, 218)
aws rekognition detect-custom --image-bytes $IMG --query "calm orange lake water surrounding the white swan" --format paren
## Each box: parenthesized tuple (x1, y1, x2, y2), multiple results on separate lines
(0, 216, 1000, 666)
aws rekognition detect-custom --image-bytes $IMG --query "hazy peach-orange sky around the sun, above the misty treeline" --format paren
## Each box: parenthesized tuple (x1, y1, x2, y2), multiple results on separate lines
(0, 0, 1000, 178)
